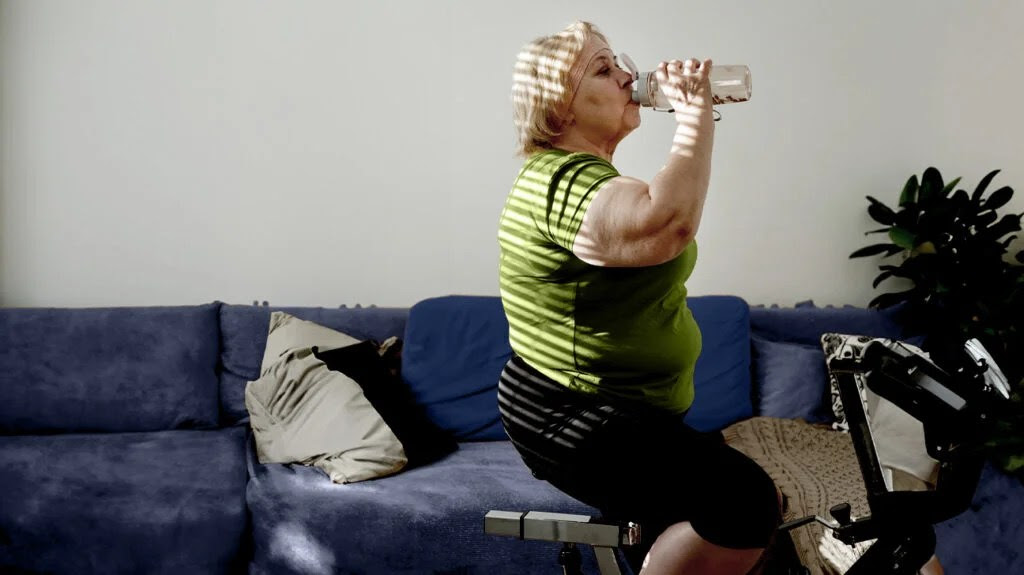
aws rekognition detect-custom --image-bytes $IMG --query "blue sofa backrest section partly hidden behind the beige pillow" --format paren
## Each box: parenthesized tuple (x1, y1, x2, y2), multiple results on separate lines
(220, 304, 409, 425)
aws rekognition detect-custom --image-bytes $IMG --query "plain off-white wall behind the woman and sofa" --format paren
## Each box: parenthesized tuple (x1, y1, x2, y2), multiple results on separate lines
(0, 0, 1024, 306)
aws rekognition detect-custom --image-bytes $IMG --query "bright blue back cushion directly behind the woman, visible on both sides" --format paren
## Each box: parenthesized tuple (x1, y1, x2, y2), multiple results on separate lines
(401, 296, 753, 441)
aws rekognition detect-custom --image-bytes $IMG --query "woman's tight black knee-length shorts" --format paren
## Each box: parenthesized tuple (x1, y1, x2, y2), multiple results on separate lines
(498, 356, 780, 563)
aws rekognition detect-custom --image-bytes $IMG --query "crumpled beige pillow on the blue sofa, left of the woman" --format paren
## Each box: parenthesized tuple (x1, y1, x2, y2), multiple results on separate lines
(246, 311, 408, 483)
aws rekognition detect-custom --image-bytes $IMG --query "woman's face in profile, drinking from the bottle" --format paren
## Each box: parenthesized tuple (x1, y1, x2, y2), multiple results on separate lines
(569, 38, 640, 142)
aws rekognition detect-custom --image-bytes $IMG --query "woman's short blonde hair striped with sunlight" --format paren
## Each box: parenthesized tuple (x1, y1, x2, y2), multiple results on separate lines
(512, 20, 608, 157)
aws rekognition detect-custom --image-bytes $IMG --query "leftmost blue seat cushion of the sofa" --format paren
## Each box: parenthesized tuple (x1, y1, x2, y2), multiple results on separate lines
(0, 428, 247, 575)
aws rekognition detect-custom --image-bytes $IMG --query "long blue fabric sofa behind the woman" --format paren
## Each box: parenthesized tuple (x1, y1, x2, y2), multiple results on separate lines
(0, 296, 1024, 575)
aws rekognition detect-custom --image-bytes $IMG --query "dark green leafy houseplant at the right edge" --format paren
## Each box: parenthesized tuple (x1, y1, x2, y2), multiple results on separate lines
(850, 167, 1024, 479)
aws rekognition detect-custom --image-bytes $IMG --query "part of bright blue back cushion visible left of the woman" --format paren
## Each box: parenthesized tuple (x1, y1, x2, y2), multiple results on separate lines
(401, 296, 512, 441)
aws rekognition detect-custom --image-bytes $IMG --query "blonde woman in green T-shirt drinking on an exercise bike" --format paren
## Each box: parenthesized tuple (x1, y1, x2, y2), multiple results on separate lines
(499, 23, 779, 575)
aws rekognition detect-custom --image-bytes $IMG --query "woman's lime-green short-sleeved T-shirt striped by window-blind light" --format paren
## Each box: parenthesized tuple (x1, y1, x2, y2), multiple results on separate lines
(498, 149, 700, 412)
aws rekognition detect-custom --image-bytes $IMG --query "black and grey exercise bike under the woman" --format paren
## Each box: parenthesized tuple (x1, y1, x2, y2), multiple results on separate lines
(484, 340, 1010, 575)
